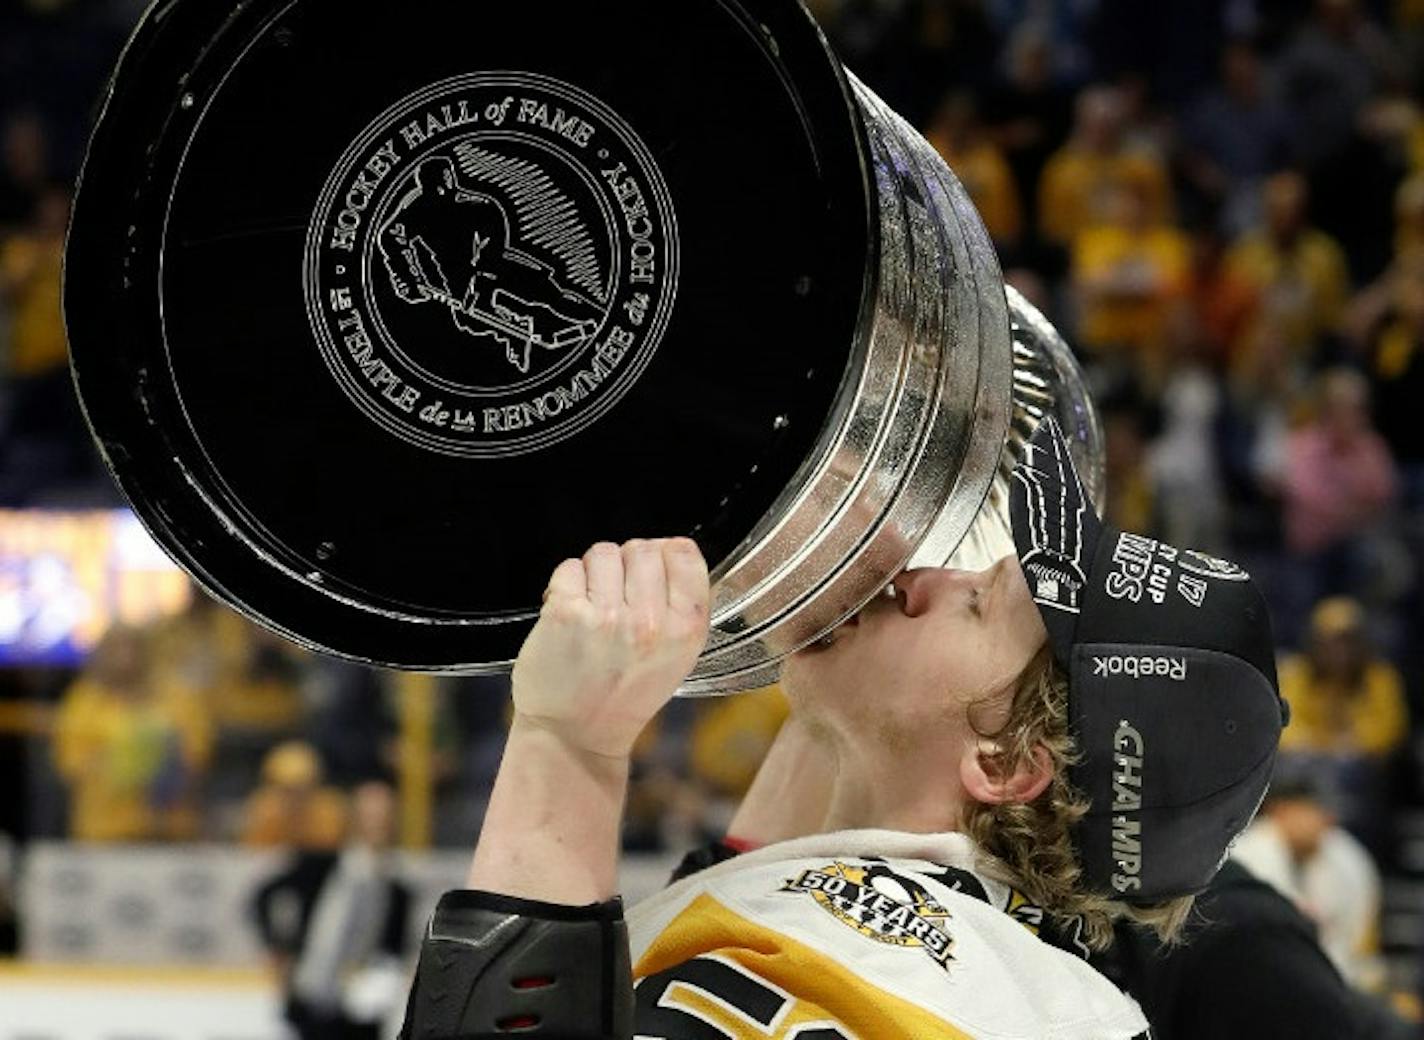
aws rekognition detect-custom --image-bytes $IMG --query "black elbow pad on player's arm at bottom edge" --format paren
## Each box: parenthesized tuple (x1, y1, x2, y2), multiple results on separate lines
(400, 892, 632, 1040)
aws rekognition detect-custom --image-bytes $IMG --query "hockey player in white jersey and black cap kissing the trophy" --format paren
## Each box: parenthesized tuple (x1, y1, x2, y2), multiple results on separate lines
(404, 420, 1284, 1040)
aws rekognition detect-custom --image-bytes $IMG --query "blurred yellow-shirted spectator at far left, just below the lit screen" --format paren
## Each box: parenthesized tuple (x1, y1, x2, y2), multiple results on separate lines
(54, 625, 212, 842)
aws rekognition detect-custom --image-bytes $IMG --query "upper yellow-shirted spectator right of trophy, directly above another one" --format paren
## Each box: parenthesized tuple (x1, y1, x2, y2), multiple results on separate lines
(1038, 87, 1172, 246)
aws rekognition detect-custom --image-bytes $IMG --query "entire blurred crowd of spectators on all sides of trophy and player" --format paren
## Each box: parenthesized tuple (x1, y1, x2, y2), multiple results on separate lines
(0, 0, 1424, 1020)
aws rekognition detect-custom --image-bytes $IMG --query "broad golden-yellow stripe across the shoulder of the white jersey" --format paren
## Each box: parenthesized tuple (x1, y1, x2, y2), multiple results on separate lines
(632, 895, 974, 1040)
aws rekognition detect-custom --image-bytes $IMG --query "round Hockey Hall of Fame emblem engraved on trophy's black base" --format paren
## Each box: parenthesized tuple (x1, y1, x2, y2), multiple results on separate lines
(305, 73, 678, 457)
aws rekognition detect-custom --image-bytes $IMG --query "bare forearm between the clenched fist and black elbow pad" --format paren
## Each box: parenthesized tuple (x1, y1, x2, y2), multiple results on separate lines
(468, 717, 628, 906)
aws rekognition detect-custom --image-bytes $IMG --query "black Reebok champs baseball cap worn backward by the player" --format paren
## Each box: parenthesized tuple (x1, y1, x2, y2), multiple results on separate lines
(1010, 417, 1289, 903)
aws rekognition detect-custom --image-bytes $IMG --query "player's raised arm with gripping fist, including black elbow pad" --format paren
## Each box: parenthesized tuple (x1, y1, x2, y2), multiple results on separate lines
(402, 539, 711, 1040)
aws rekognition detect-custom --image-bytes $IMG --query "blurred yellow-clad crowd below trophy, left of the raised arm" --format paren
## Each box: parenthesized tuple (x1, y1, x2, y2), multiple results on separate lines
(4, 578, 524, 851)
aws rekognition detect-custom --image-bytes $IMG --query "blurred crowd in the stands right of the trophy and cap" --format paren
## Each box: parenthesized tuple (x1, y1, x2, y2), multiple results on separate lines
(820, 0, 1424, 1008)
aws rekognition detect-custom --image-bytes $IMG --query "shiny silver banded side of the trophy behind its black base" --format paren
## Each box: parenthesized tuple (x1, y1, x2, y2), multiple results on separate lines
(684, 77, 1012, 694)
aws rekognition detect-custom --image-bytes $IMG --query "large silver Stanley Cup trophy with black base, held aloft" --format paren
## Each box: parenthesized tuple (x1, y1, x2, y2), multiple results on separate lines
(66, 0, 1102, 694)
